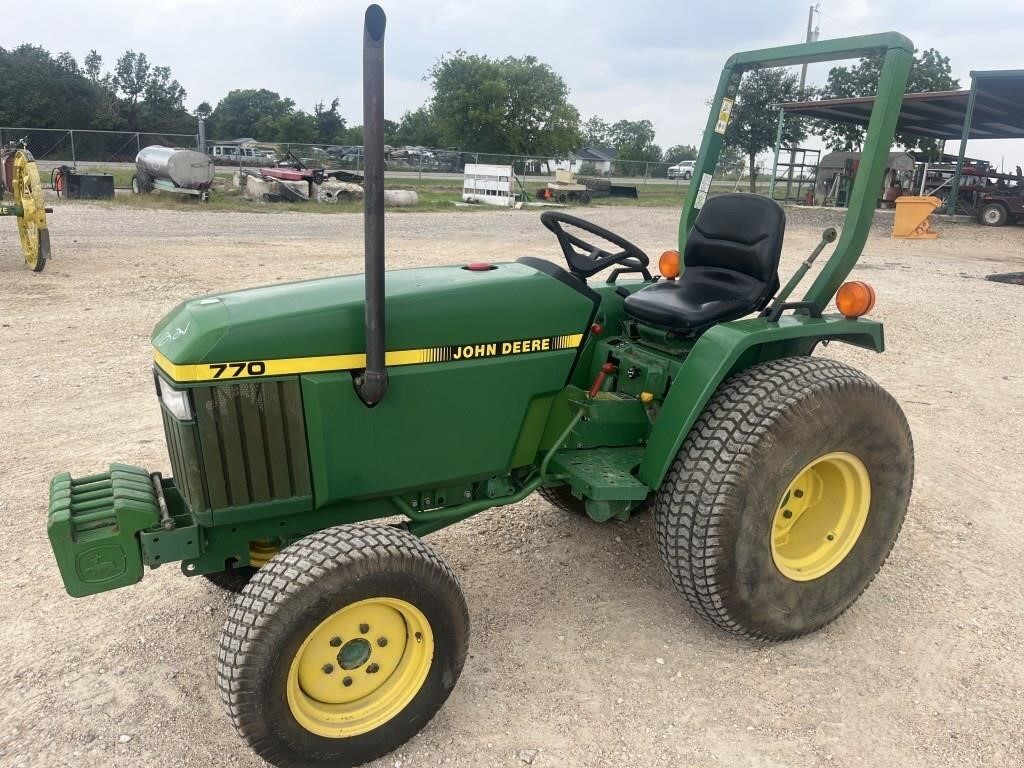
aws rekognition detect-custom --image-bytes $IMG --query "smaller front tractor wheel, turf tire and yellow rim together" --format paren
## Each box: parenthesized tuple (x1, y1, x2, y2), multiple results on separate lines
(217, 525, 469, 768)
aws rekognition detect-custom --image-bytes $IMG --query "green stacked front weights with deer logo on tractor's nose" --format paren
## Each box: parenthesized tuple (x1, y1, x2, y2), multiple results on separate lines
(46, 464, 160, 597)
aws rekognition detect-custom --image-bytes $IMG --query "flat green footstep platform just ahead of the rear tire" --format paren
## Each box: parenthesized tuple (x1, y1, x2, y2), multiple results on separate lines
(549, 446, 650, 502)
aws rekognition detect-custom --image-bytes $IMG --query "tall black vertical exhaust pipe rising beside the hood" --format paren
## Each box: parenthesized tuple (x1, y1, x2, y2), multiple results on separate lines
(356, 5, 387, 406)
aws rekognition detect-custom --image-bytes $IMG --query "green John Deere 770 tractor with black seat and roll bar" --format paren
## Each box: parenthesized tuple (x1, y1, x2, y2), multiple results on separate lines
(48, 6, 913, 767)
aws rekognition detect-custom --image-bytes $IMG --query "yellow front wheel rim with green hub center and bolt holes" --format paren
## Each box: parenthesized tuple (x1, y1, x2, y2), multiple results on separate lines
(287, 597, 434, 738)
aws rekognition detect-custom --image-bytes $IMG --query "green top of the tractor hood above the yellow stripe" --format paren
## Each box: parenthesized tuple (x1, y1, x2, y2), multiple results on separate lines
(153, 263, 594, 380)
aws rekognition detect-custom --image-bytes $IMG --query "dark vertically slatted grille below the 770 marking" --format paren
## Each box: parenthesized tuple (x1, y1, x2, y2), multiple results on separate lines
(164, 379, 310, 511)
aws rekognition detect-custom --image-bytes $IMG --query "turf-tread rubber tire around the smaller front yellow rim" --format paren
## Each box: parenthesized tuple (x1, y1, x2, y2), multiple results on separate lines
(217, 524, 469, 768)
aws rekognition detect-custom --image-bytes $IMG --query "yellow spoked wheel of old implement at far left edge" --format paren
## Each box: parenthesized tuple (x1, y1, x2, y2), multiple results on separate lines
(0, 141, 51, 272)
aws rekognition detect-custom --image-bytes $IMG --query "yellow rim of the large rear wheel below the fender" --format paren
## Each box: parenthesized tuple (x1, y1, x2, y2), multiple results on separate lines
(771, 452, 871, 582)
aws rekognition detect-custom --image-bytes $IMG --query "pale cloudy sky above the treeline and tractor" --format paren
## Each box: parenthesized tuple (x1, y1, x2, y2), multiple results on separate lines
(8, 0, 1024, 167)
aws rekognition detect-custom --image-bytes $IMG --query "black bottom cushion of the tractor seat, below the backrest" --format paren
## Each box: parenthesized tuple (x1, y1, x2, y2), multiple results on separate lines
(626, 266, 777, 333)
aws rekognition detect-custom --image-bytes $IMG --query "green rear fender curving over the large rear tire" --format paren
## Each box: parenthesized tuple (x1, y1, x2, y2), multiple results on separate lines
(638, 314, 885, 488)
